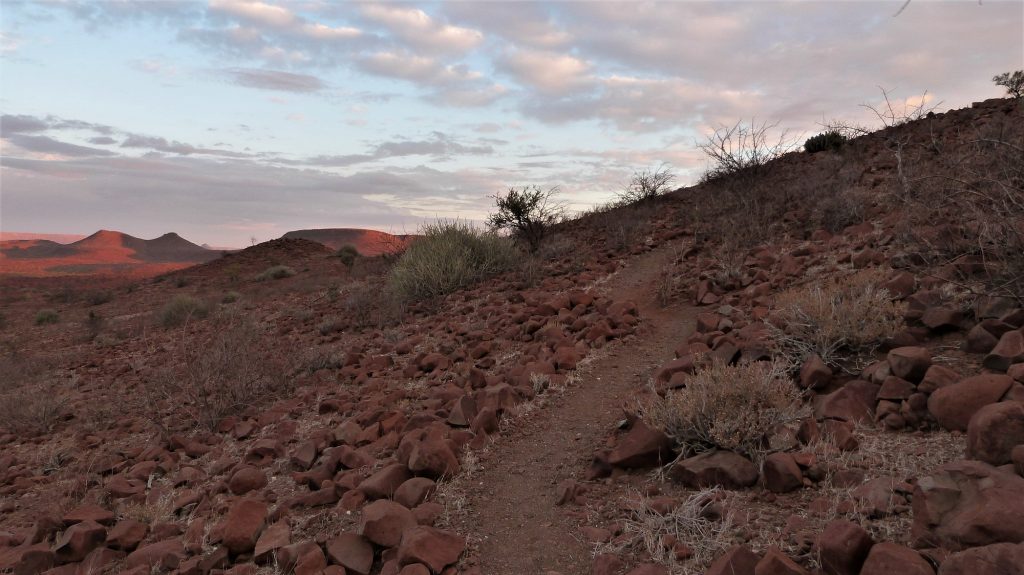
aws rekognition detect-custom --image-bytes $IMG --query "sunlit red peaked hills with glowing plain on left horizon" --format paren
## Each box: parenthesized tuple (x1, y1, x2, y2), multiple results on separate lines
(0, 229, 220, 275)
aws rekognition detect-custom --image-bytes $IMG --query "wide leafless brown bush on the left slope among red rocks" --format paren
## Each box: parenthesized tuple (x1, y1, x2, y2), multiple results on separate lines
(143, 315, 294, 429)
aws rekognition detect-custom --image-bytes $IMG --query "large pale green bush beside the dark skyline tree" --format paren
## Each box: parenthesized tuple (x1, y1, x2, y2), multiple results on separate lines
(390, 221, 521, 301)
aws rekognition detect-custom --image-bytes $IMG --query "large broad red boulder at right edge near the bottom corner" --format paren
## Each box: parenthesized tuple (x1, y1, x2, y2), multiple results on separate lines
(910, 460, 1024, 550)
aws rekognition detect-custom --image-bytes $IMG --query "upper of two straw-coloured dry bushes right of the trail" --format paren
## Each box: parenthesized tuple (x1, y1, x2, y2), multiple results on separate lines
(768, 270, 904, 367)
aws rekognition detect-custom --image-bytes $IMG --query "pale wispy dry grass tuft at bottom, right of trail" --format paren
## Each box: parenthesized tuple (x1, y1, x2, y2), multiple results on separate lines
(597, 487, 736, 574)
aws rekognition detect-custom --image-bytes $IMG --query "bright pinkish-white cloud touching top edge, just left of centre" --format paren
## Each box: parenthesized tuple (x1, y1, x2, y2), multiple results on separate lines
(361, 4, 483, 54)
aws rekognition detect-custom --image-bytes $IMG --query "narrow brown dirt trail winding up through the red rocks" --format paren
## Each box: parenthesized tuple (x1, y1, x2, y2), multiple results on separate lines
(466, 246, 695, 575)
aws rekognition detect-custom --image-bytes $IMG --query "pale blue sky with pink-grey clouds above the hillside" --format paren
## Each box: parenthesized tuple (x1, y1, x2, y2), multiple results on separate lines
(0, 0, 1024, 247)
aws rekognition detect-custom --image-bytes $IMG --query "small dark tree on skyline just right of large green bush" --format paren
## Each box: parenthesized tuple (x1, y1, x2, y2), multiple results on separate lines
(487, 185, 564, 252)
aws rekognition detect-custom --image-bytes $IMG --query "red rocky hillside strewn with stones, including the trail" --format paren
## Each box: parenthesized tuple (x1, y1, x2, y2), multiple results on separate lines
(0, 96, 1024, 575)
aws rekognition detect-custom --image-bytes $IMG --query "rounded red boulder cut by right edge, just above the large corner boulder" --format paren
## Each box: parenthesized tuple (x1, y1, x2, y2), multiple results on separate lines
(967, 401, 1024, 466)
